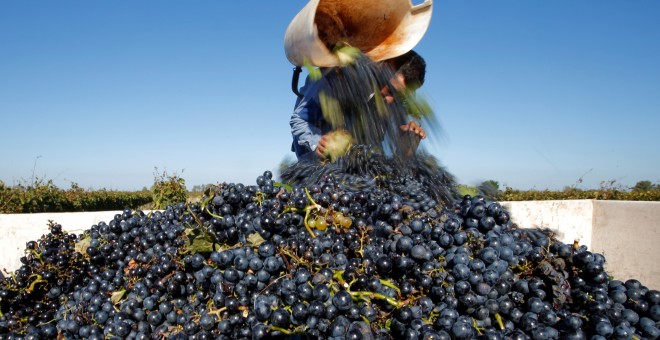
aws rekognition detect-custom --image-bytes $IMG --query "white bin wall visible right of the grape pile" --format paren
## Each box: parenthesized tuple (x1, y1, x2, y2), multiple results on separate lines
(502, 200, 660, 289)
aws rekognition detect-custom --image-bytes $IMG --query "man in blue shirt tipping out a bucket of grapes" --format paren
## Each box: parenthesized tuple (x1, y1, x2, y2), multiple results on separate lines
(290, 51, 426, 161)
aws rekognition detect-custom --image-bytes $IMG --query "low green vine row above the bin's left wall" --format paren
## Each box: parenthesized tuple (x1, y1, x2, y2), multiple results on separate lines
(0, 179, 151, 213)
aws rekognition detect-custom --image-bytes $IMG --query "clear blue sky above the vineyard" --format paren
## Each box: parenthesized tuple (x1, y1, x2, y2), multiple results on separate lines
(0, 0, 660, 190)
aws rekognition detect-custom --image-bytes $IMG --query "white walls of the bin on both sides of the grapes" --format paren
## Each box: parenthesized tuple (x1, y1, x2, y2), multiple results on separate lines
(0, 200, 660, 289)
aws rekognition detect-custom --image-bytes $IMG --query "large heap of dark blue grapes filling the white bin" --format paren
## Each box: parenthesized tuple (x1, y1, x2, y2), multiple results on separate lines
(0, 172, 660, 339)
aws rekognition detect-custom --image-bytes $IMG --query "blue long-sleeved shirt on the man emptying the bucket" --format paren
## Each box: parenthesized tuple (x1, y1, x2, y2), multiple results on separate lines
(289, 72, 335, 160)
